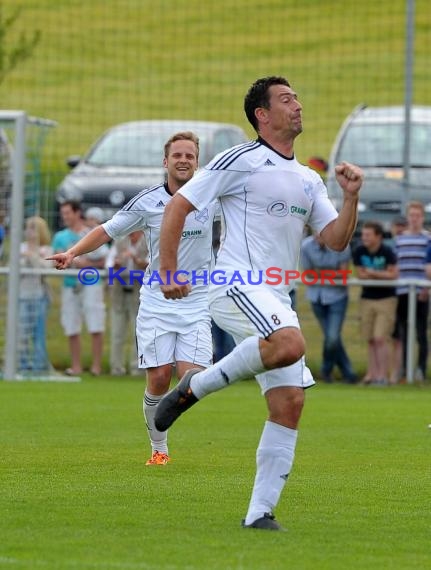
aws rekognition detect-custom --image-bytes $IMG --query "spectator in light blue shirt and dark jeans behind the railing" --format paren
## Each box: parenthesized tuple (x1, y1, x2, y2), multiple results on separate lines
(301, 234, 357, 384)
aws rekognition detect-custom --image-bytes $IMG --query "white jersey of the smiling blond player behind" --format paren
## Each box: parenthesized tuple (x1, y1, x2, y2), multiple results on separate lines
(103, 184, 216, 326)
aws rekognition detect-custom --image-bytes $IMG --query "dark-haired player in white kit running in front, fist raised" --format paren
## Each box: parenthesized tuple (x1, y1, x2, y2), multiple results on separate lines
(155, 77, 362, 530)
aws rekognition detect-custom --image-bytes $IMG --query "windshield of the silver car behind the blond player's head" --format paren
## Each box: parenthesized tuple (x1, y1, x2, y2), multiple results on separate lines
(86, 129, 209, 167)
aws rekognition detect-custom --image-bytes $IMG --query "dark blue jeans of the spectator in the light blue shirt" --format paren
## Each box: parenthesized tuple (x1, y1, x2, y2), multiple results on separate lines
(311, 297, 356, 380)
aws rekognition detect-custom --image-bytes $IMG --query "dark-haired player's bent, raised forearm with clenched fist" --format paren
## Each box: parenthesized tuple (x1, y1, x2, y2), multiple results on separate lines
(320, 162, 363, 251)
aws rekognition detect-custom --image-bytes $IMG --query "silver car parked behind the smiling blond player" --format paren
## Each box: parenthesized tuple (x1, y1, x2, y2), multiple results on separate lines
(57, 120, 248, 219)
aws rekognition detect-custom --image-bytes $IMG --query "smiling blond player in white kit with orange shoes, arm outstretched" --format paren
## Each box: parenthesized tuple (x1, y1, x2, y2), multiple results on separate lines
(51, 132, 216, 465)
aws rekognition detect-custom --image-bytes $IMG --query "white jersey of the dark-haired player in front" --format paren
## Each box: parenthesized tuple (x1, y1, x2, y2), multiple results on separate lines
(179, 139, 338, 301)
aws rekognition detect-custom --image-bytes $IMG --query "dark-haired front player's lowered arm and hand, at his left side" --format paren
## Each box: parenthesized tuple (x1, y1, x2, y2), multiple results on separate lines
(160, 194, 195, 299)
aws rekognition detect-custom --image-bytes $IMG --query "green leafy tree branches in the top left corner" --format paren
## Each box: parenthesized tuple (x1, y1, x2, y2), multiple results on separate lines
(0, 4, 41, 84)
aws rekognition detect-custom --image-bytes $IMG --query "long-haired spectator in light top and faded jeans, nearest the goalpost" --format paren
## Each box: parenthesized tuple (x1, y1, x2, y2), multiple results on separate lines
(18, 216, 52, 372)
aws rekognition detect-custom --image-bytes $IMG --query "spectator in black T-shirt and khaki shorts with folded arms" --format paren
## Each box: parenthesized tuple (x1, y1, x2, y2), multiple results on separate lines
(353, 221, 398, 384)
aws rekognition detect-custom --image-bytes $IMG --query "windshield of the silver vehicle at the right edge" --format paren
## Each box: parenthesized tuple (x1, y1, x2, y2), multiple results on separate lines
(337, 123, 431, 168)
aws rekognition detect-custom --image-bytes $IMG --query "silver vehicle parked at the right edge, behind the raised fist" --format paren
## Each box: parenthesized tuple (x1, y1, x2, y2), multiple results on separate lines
(327, 105, 431, 231)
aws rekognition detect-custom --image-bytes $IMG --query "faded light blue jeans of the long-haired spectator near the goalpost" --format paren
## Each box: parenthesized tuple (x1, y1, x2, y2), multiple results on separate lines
(19, 296, 51, 371)
